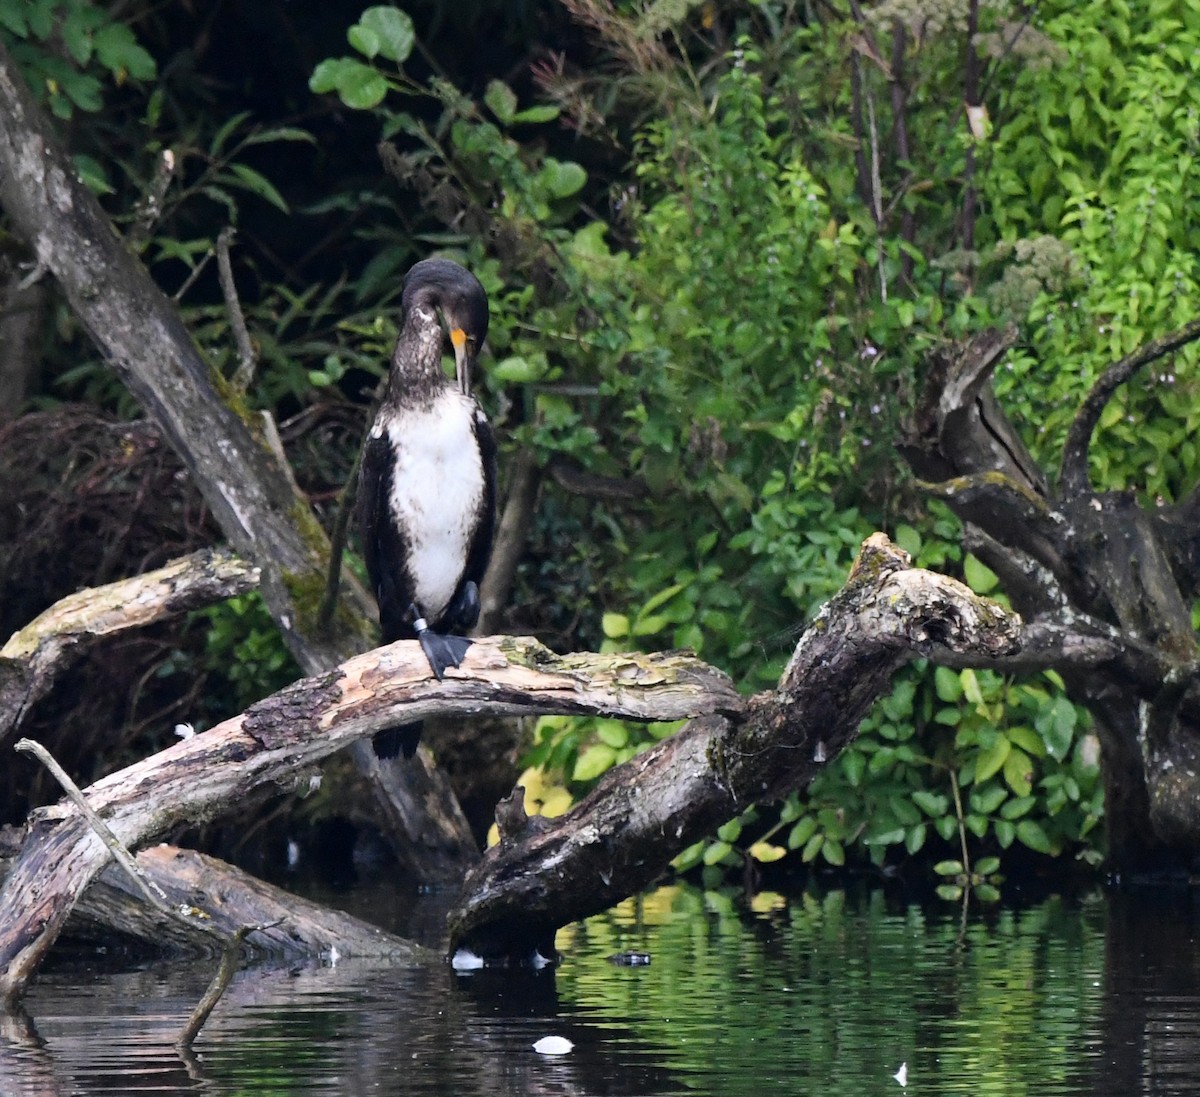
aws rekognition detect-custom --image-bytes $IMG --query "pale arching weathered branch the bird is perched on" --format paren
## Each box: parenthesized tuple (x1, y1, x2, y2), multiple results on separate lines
(0, 637, 744, 1001)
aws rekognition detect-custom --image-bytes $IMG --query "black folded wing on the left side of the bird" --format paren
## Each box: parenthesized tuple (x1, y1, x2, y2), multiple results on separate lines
(359, 433, 415, 643)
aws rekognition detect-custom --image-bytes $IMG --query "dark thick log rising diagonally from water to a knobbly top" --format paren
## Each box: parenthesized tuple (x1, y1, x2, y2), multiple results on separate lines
(450, 534, 1020, 960)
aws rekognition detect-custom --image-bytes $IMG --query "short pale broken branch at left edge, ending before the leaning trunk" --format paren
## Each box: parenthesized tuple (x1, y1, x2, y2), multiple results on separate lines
(0, 550, 259, 743)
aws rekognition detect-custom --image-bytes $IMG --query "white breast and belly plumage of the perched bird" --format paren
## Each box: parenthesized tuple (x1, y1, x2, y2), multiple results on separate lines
(388, 389, 484, 621)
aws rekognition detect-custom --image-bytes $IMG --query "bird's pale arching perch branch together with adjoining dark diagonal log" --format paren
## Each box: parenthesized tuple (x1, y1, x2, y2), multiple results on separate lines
(0, 534, 1019, 1001)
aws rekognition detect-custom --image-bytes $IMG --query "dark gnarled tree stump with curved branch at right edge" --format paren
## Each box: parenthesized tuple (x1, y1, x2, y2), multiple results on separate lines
(902, 320, 1200, 871)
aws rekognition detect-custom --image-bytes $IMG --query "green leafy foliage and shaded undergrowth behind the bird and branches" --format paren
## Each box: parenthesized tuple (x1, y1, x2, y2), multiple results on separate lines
(0, 0, 1200, 897)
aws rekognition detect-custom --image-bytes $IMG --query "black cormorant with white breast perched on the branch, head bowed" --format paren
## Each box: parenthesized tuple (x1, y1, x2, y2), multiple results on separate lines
(359, 259, 496, 757)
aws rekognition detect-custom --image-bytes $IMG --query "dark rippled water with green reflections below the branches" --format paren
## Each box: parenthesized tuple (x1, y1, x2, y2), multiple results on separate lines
(0, 888, 1200, 1097)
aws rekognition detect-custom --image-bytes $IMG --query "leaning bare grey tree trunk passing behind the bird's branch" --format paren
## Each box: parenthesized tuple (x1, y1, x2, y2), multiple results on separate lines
(0, 38, 478, 880)
